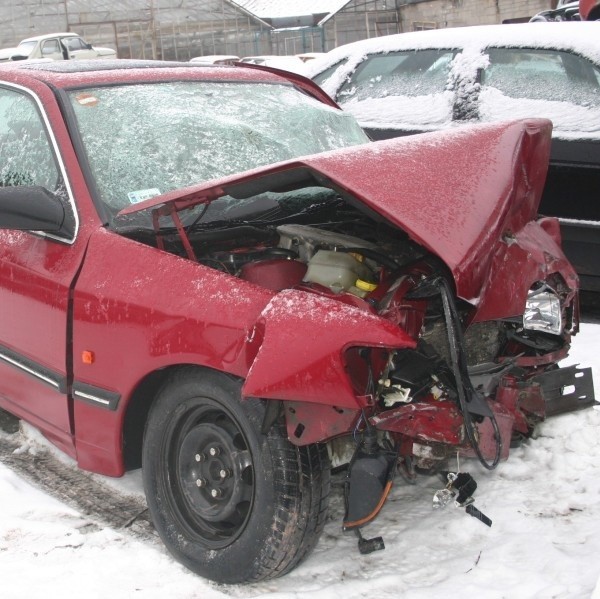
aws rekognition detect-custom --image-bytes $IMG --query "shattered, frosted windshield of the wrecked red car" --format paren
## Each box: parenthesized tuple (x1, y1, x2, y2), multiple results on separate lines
(69, 81, 368, 219)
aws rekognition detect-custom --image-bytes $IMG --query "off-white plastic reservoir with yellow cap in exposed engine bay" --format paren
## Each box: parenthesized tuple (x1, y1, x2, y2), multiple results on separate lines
(303, 250, 373, 293)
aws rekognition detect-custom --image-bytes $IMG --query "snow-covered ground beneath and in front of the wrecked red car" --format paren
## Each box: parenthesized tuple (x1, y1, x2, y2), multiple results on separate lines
(0, 324, 600, 599)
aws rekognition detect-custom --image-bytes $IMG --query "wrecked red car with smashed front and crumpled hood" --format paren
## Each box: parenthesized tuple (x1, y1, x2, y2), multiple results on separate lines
(0, 61, 594, 583)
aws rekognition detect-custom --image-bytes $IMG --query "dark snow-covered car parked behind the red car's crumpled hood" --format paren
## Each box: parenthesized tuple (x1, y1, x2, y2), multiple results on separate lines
(310, 22, 600, 292)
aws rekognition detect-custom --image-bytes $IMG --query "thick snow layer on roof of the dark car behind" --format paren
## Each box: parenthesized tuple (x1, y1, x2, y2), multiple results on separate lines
(310, 21, 600, 76)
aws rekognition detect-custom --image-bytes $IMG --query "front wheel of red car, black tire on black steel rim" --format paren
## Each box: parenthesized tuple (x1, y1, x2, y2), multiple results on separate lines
(142, 368, 330, 584)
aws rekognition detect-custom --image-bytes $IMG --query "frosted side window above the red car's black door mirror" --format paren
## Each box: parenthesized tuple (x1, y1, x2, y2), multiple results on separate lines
(0, 88, 65, 194)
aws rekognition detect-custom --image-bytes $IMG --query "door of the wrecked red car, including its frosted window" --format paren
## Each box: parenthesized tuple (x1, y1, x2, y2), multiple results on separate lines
(0, 86, 85, 454)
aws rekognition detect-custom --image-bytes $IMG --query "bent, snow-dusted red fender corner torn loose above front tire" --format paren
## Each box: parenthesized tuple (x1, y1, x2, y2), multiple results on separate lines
(242, 290, 416, 409)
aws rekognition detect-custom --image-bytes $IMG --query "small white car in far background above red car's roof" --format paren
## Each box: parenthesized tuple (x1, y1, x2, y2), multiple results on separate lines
(0, 33, 117, 62)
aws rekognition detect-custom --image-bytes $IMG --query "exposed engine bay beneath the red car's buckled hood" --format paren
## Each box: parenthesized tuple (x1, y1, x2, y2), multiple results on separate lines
(117, 185, 563, 365)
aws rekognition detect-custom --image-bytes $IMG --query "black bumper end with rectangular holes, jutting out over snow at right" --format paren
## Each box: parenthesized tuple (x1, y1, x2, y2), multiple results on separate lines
(532, 365, 598, 417)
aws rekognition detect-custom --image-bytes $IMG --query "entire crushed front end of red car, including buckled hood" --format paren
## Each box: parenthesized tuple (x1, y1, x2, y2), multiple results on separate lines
(121, 120, 595, 551)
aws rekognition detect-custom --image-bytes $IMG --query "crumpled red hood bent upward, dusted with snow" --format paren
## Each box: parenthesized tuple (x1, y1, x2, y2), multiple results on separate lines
(120, 119, 552, 300)
